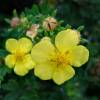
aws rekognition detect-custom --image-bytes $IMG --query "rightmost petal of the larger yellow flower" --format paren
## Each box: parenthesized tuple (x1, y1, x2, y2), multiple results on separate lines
(71, 45, 89, 67)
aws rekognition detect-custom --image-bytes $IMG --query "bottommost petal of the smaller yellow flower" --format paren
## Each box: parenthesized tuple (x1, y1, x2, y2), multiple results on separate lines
(14, 62, 29, 76)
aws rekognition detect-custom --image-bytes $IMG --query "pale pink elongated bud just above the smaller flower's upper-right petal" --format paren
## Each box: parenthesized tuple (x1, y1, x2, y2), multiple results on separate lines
(26, 24, 39, 39)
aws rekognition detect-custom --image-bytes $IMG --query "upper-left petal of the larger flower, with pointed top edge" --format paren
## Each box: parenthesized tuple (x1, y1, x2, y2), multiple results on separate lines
(31, 37, 55, 63)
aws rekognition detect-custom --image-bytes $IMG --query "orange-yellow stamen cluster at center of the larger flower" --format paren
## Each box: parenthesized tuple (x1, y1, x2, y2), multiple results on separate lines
(51, 52, 70, 66)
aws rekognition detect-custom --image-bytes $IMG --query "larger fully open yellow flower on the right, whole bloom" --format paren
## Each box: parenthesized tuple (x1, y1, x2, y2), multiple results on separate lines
(31, 29, 89, 85)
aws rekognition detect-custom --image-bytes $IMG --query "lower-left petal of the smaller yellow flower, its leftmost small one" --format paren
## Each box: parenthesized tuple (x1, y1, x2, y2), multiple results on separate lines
(5, 55, 16, 68)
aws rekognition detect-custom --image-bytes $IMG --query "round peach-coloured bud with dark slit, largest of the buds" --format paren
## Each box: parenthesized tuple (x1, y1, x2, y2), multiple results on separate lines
(43, 17, 58, 31)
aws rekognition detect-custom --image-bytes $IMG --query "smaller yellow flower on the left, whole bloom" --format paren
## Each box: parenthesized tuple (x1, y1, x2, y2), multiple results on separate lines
(5, 38, 35, 76)
